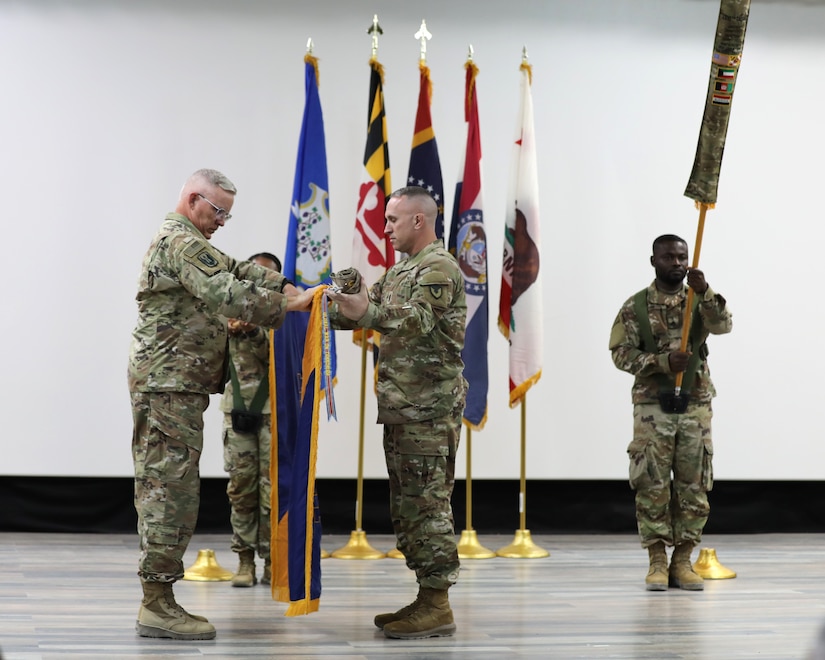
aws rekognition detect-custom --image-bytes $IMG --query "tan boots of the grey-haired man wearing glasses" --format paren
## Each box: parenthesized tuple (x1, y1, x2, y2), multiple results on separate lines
(135, 582, 215, 639)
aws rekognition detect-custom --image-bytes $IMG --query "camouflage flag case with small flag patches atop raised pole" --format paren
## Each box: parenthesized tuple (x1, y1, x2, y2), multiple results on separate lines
(685, 0, 751, 206)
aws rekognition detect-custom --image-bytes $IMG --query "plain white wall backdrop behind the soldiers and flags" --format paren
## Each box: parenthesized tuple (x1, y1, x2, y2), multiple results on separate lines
(0, 0, 825, 479)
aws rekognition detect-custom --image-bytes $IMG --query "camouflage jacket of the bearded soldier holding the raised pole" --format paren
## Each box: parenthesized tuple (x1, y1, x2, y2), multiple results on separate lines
(610, 281, 733, 403)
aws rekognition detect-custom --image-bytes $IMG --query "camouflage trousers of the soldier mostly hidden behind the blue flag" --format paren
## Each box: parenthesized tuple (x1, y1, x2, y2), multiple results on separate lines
(223, 413, 272, 559)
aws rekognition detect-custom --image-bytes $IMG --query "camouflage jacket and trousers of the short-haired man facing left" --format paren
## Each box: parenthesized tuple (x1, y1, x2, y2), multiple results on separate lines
(331, 240, 467, 589)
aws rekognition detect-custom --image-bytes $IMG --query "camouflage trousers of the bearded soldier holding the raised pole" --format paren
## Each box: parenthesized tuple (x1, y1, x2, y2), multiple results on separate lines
(627, 403, 713, 547)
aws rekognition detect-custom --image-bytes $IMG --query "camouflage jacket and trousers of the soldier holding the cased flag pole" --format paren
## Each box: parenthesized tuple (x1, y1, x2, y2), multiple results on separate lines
(610, 281, 732, 547)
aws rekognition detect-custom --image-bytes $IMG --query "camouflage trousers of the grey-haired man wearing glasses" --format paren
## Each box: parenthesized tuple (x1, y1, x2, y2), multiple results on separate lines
(131, 392, 209, 582)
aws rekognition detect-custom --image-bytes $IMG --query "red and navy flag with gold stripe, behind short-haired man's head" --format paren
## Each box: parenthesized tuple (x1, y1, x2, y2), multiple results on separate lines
(407, 62, 444, 240)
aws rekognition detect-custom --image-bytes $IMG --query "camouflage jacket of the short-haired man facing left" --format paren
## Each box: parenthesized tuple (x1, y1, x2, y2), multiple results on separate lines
(330, 241, 467, 424)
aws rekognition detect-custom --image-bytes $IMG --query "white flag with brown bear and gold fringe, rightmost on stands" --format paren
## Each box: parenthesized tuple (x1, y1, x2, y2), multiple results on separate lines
(498, 62, 544, 408)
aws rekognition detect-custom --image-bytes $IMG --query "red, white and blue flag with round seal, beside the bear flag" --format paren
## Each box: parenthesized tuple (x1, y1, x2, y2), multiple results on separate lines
(448, 61, 490, 430)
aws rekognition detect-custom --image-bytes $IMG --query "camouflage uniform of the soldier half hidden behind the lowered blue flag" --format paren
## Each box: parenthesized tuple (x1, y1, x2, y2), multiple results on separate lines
(221, 328, 272, 559)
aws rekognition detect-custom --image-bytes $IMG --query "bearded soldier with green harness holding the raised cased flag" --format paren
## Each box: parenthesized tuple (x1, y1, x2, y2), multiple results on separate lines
(610, 234, 733, 591)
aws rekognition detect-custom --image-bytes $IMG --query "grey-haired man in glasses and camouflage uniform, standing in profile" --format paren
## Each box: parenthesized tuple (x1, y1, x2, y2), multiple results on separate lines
(129, 170, 311, 639)
